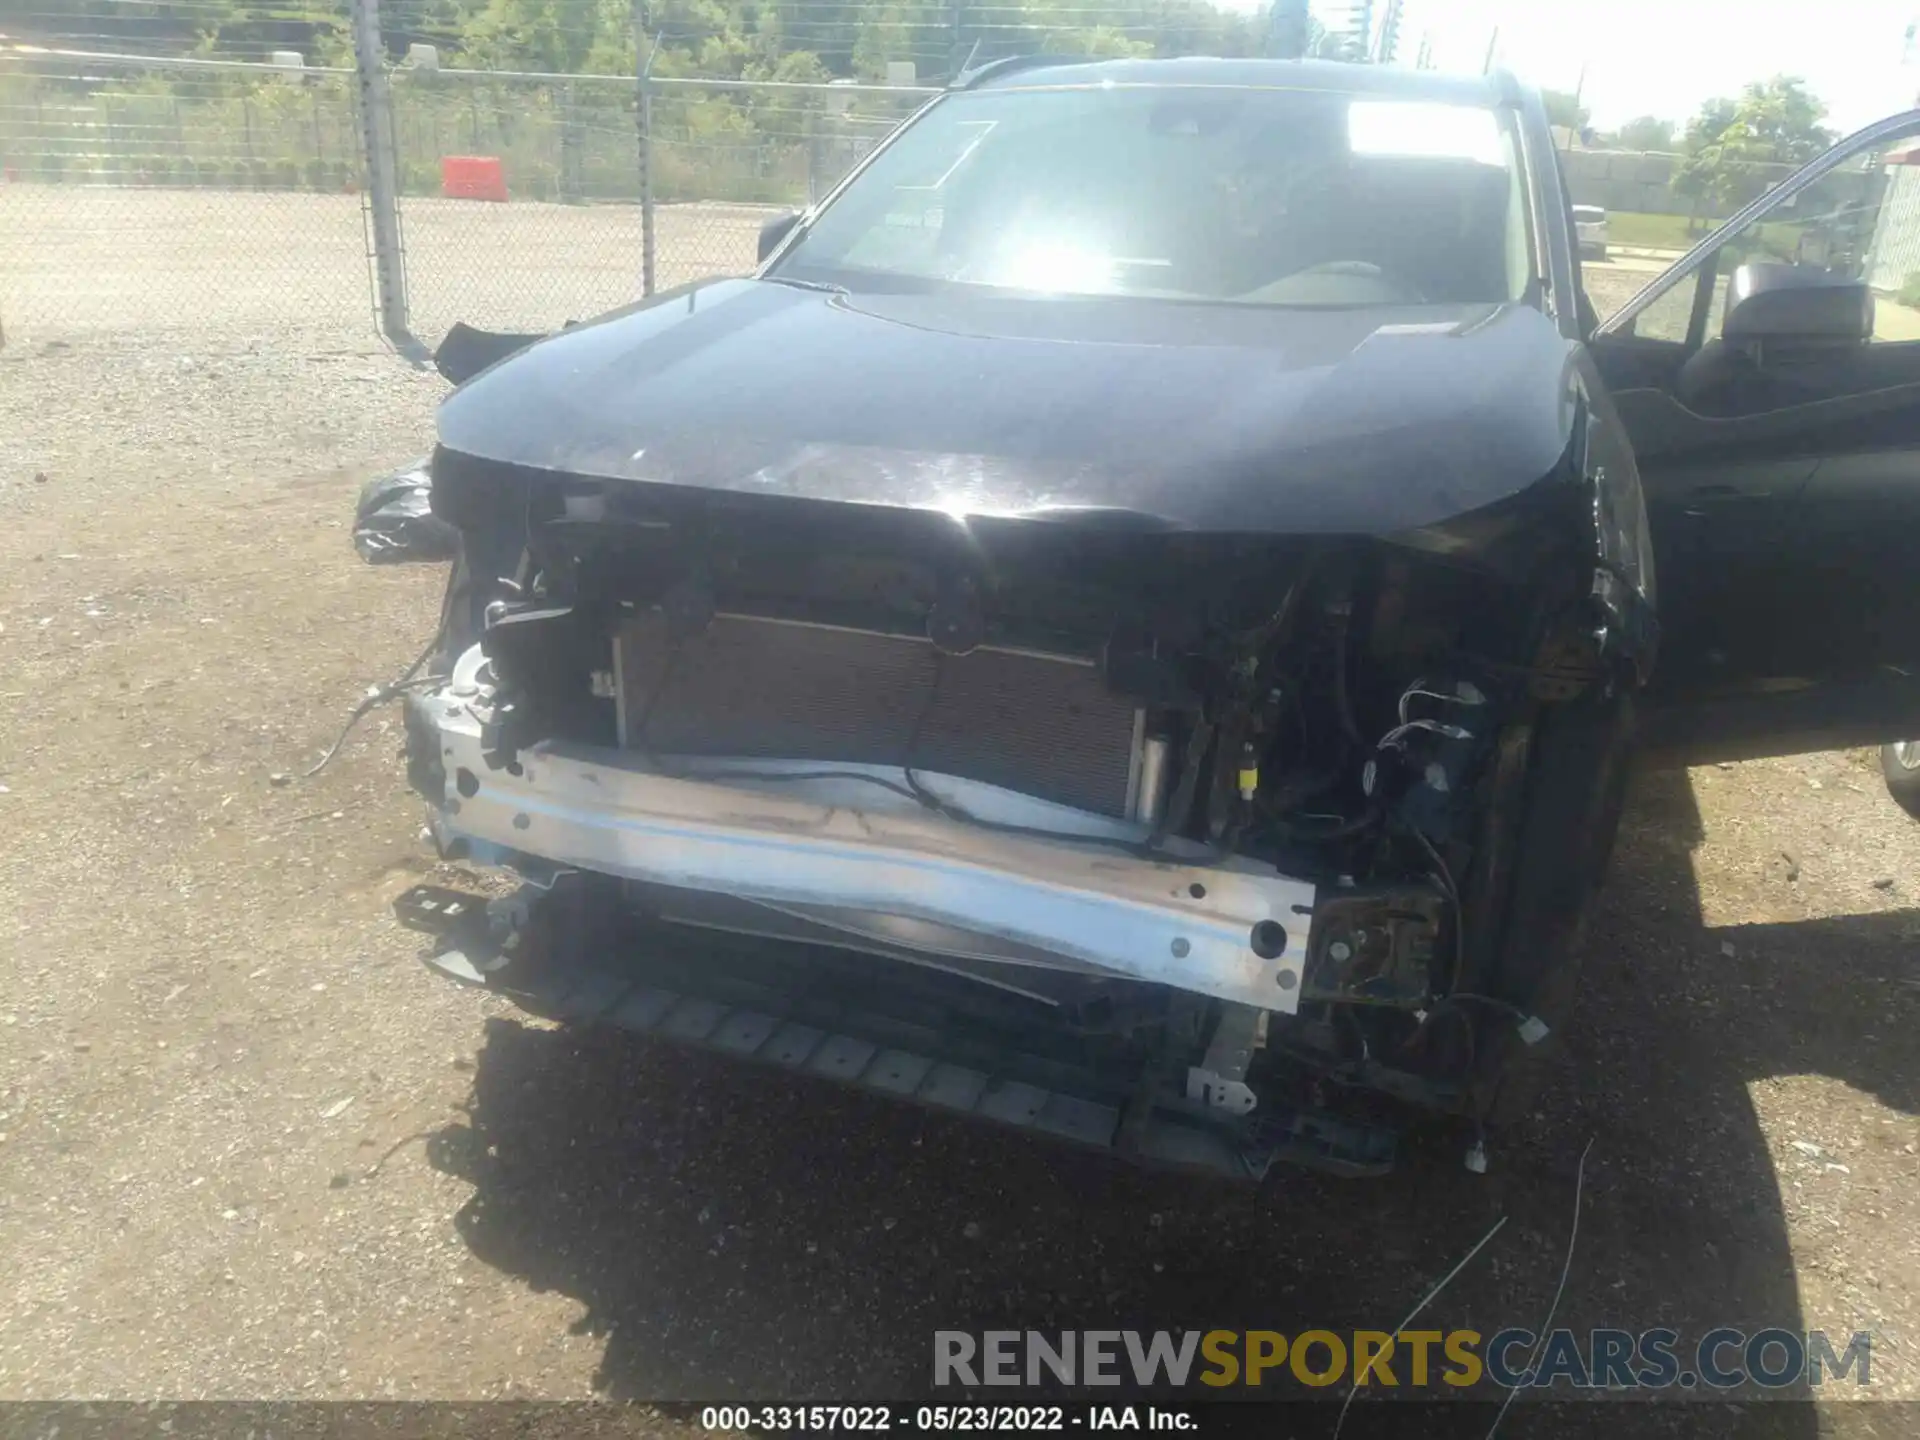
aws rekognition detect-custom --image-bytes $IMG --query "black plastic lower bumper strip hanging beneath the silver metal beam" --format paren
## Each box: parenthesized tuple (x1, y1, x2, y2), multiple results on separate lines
(396, 885, 1398, 1181)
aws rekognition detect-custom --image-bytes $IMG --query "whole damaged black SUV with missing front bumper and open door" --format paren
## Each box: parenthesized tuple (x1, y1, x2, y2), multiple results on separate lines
(382, 60, 1920, 1177)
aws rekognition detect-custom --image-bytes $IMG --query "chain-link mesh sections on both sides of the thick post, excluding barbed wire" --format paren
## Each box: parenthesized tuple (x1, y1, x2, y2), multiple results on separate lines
(0, 35, 933, 346)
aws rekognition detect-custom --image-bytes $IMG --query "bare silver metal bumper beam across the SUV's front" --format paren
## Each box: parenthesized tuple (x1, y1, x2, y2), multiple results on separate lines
(409, 655, 1315, 1014)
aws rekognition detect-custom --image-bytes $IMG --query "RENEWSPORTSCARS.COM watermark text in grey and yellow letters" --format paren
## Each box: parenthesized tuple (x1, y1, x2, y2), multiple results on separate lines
(933, 1329, 1872, 1390)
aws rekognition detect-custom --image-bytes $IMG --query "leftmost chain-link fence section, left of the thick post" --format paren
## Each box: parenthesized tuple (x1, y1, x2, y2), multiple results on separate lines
(0, 54, 369, 344)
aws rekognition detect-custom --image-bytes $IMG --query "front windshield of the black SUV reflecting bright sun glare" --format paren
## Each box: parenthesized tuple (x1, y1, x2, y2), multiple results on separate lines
(770, 86, 1532, 305)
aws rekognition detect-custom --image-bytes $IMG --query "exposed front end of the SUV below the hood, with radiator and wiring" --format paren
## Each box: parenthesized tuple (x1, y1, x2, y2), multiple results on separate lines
(420, 451, 1592, 1152)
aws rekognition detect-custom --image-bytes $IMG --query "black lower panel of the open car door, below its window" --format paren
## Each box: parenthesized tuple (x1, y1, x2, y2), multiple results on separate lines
(1620, 388, 1920, 762)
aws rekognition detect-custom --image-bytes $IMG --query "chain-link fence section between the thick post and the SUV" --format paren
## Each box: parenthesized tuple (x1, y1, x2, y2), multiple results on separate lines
(392, 69, 933, 340)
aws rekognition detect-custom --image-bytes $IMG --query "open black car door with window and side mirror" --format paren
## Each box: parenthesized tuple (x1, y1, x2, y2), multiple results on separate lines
(1586, 111, 1920, 764)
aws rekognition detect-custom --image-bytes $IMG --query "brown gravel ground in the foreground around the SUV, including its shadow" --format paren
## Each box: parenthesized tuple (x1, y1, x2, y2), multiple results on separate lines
(0, 247, 1920, 1436)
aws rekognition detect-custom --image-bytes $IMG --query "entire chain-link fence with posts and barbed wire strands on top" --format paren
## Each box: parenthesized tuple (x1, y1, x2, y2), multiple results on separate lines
(0, 0, 1290, 348)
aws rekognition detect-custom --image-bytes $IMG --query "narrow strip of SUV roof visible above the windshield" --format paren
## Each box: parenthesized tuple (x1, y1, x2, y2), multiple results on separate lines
(956, 56, 1521, 106)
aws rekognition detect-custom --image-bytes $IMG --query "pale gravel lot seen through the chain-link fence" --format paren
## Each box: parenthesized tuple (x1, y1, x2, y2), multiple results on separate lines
(0, 184, 776, 348)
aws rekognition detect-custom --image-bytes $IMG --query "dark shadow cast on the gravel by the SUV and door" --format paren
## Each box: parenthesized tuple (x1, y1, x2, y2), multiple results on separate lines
(428, 776, 1920, 1436)
